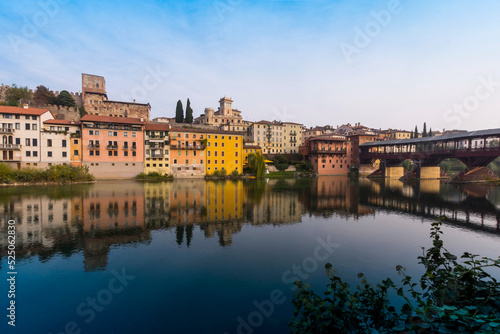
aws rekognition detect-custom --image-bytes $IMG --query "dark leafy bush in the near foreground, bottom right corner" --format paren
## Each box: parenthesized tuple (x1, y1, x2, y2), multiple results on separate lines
(289, 217, 500, 334)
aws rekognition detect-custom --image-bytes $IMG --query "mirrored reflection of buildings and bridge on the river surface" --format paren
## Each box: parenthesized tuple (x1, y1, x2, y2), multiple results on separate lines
(0, 176, 500, 271)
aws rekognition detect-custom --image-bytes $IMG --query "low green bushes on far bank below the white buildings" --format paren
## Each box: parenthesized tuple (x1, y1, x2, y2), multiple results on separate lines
(0, 163, 94, 183)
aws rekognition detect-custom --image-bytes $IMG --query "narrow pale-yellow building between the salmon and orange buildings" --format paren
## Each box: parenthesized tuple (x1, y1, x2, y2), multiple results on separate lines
(144, 123, 170, 175)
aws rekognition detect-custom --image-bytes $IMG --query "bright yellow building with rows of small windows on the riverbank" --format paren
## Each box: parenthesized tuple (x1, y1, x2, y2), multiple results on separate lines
(205, 131, 244, 175)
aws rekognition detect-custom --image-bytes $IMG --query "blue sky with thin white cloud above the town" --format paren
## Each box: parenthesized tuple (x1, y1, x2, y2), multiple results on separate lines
(0, 0, 500, 130)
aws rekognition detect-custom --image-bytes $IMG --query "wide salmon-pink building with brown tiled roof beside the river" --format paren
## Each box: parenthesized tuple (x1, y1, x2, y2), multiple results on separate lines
(80, 115, 145, 179)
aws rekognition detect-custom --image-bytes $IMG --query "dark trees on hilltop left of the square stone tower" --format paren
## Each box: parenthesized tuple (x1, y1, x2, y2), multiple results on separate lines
(0, 84, 77, 107)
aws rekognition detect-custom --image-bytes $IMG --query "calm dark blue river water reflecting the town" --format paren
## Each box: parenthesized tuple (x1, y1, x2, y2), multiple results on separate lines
(0, 177, 500, 334)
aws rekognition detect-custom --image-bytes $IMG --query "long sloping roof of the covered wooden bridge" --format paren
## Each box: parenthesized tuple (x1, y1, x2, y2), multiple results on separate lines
(359, 129, 500, 147)
